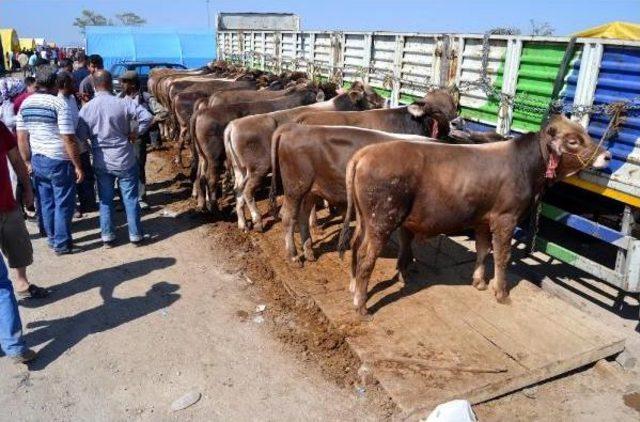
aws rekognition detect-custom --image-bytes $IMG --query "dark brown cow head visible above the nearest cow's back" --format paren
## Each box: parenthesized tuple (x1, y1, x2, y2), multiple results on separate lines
(407, 87, 459, 138)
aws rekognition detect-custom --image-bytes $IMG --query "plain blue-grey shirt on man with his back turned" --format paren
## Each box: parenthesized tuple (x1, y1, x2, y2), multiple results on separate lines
(77, 91, 153, 171)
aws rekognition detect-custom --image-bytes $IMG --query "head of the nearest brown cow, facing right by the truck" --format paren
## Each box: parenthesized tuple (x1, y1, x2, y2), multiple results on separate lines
(540, 115, 611, 179)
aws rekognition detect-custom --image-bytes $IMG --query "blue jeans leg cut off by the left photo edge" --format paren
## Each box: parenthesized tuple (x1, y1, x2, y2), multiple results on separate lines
(0, 257, 27, 356)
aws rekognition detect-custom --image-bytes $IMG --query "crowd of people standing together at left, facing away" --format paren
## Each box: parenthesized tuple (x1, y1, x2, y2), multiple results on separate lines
(0, 52, 156, 363)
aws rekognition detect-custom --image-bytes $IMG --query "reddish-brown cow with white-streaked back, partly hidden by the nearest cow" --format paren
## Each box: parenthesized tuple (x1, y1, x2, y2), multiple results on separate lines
(271, 123, 433, 267)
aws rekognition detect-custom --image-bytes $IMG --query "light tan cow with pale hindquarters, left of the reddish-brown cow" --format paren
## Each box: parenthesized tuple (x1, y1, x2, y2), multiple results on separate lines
(224, 83, 384, 231)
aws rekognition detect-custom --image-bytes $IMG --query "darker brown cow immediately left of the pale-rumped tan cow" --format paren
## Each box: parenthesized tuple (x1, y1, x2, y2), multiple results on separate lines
(192, 83, 328, 211)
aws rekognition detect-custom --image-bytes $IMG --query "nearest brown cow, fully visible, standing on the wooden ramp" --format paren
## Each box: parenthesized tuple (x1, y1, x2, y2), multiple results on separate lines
(339, 116, 611, 315)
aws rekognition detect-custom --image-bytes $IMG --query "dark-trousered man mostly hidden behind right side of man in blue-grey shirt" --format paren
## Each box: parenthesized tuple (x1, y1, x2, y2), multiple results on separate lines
(118, 70, 152, 210)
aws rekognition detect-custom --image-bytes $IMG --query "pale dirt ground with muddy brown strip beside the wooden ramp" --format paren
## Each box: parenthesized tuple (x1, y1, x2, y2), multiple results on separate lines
(0, 148, 640, 421)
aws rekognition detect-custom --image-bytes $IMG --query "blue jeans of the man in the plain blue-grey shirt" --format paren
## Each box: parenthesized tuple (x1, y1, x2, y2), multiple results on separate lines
(95, 165, 143, 242)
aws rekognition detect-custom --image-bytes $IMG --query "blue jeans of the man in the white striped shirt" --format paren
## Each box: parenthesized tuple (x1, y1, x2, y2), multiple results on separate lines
(31, 154, 76, 252)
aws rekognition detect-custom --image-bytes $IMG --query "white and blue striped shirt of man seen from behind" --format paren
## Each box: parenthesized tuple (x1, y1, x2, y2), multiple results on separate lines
(16, 92, 75, 160)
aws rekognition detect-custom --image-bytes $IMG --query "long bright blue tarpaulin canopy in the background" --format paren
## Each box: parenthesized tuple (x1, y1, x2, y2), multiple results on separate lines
(86, 26, 216, 69)
